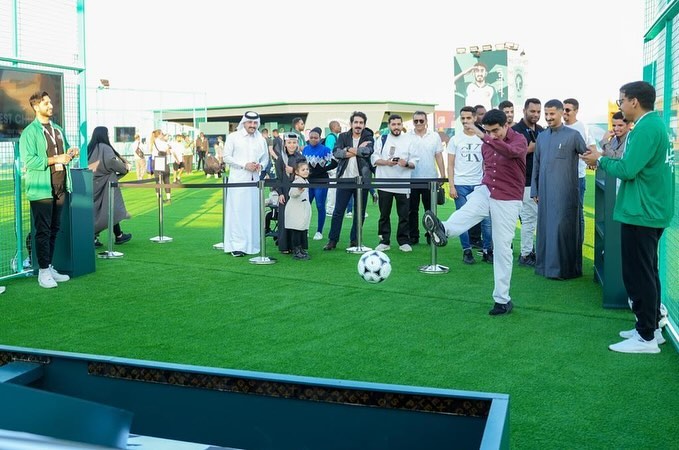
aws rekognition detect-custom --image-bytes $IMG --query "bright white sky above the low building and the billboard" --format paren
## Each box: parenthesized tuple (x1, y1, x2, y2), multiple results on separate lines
(85, 0, 644, 123)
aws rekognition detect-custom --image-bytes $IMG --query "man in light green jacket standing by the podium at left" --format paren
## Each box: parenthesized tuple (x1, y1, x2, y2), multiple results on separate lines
(19, 92, 79, 288)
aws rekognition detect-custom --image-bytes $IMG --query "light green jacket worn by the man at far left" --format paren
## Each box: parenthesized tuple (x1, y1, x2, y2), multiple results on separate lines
(19, 119, 71, 201)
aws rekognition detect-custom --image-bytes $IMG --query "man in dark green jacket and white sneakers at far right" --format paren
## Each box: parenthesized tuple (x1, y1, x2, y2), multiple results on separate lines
(582, 81, 674, 353)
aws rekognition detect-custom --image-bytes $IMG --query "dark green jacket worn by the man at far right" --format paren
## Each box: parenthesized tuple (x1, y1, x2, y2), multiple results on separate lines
(599, 111, 674, 228)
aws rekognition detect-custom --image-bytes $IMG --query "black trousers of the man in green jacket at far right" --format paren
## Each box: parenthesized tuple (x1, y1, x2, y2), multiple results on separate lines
(620, 223, 664, 341)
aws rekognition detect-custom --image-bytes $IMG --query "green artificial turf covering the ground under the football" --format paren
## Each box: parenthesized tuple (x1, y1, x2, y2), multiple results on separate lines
(0, 171, 679, 449)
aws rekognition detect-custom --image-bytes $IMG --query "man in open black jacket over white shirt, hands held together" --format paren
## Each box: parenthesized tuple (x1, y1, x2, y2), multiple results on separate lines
(323, 111, 375, 250)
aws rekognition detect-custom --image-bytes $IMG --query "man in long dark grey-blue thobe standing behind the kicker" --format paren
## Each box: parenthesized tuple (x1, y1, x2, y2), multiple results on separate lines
(530, 100, 587, 280)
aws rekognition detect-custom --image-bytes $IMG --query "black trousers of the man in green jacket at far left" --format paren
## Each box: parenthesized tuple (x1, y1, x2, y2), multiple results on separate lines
(31, 194, 66, 269)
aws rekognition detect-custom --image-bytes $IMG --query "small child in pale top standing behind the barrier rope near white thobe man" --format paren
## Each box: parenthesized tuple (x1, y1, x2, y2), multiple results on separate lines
(285, 160, 311, 260)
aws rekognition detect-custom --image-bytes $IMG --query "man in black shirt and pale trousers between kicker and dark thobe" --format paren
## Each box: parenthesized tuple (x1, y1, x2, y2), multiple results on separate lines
(512, 98, 544, 267)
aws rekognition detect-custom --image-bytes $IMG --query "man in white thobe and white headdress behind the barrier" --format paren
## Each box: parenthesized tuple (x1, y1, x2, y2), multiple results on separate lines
(224, 111, 269, 257)
